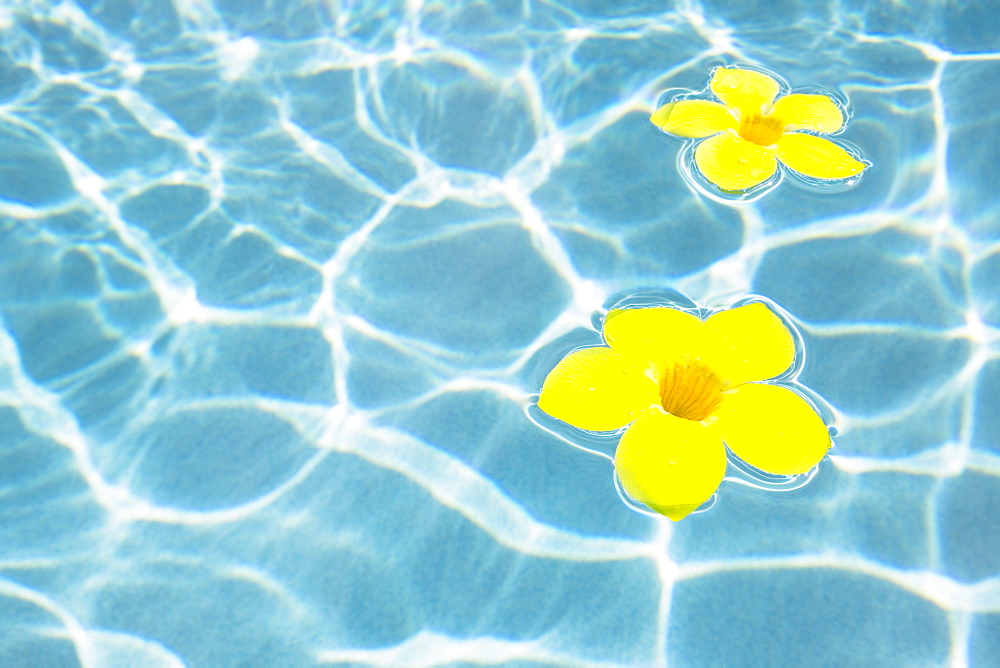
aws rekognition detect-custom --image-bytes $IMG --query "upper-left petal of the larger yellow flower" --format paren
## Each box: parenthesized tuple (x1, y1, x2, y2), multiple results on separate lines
(604, 307, 705, 363)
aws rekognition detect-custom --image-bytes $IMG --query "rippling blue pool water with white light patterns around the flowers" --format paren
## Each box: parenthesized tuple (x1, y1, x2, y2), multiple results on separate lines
(0, 0, 1000, 668)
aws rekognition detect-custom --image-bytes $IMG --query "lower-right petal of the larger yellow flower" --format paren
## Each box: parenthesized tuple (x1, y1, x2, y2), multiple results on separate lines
(715, 383, 830, 475)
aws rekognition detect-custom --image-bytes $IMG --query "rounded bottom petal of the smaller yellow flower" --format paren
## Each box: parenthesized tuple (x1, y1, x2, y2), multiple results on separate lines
(694, 133, 778, 190)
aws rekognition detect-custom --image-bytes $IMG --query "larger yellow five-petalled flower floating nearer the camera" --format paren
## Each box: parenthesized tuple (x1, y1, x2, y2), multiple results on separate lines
(538, 302, 831, 521)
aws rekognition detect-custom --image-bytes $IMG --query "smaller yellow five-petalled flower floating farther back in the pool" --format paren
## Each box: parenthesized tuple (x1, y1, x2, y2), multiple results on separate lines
(649, 67, 868, 191)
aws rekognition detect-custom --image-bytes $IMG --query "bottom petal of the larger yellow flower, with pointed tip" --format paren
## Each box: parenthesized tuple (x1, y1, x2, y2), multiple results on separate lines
(615, 414, 726, 521)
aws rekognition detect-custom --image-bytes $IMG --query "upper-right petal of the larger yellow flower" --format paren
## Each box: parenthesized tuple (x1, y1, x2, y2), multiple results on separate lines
(705, 302, 795, 386)
